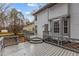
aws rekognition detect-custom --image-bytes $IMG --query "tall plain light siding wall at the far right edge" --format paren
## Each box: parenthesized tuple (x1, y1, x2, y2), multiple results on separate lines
(70, 3, 79, 39)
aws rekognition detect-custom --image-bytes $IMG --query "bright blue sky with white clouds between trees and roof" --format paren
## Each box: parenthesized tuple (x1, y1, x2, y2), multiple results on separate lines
(10, 3, 45, 21)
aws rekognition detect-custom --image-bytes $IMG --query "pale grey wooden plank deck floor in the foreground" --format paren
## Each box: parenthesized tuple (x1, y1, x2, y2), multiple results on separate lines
(0, 42, 79, 56)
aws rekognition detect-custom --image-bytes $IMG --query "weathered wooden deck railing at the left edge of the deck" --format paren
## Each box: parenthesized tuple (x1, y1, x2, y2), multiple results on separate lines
(0, 36, 19, 56)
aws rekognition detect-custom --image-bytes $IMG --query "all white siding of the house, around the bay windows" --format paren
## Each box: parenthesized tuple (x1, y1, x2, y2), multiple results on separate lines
(35, 3, 79, 39)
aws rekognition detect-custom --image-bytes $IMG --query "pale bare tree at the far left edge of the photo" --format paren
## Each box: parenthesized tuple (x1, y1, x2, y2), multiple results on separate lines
(0, 4, 10, 29)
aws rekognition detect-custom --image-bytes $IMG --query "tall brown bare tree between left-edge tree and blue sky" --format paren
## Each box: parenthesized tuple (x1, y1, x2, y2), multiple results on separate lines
(10, 9, 24, 35)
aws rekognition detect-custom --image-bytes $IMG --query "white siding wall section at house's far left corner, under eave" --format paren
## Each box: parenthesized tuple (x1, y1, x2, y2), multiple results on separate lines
(36, 10, 48, 37)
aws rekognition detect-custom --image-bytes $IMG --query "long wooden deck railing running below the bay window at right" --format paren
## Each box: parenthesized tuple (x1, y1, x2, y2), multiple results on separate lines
(43, 31, 79, 53)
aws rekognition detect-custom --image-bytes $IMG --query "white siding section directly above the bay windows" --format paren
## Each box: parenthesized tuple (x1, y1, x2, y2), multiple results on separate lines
(49, 4, 68, 19)
